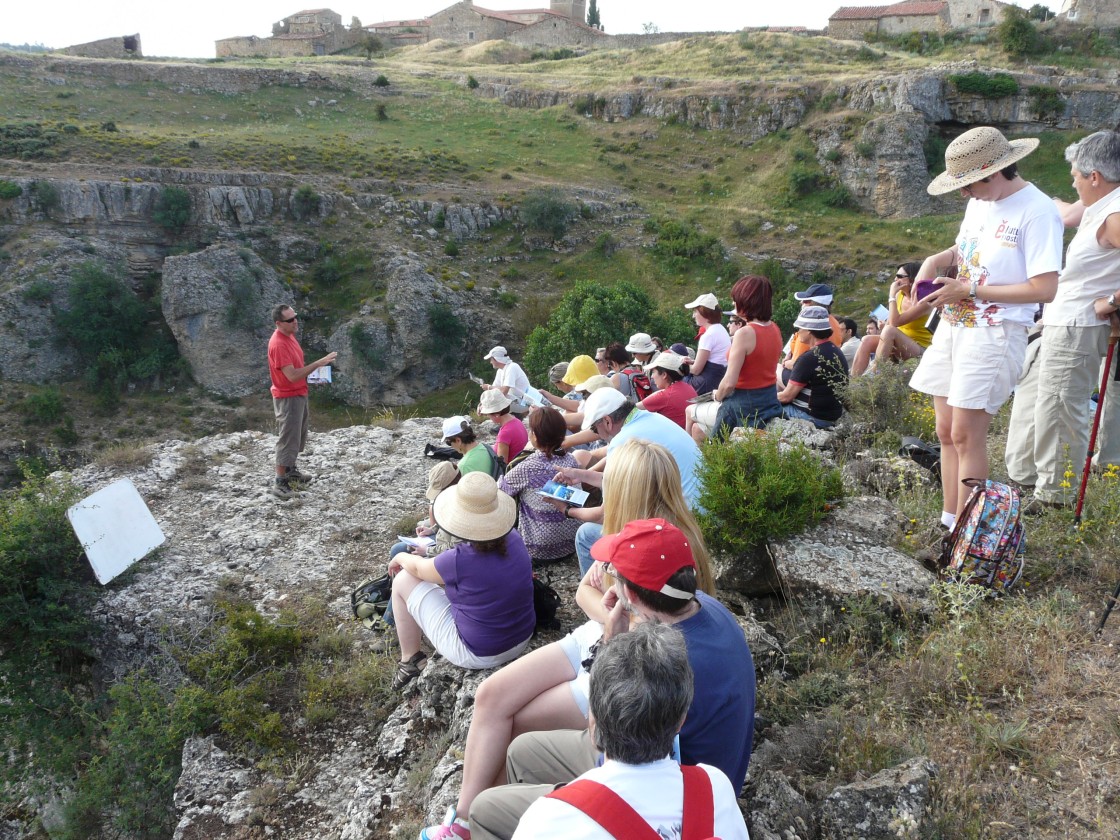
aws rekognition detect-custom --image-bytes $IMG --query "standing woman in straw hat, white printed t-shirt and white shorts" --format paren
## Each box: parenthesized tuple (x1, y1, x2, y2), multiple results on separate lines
(911, 127, 1062, 550)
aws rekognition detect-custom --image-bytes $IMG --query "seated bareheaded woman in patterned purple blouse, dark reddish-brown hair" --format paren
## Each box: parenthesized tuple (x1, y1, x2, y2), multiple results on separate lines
(497, 409, 579, 561)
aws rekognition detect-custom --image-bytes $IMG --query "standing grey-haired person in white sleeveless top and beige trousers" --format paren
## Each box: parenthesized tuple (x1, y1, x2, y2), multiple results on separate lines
(1006, 131, 1120, 515)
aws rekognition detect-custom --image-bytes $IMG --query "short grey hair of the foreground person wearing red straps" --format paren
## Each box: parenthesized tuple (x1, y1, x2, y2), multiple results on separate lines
(588, 622, 692, 764)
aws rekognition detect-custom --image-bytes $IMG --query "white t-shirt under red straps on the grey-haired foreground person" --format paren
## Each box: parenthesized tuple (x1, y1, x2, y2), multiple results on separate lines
(513, 758, 749, 840)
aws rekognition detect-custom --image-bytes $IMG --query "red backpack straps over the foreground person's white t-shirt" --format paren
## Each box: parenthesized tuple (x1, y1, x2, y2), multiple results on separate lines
(547, 765, 716, 840)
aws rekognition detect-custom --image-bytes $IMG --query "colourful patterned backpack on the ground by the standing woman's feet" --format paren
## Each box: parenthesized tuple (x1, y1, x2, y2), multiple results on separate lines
(941, 478, 1026, 595)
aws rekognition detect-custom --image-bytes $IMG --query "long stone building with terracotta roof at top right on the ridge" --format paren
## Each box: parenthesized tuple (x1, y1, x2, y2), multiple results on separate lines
(828, 0, 1021, 40)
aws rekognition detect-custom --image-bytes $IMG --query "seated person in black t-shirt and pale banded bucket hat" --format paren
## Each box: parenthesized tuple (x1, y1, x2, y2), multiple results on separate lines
(777, 306, 848, 429)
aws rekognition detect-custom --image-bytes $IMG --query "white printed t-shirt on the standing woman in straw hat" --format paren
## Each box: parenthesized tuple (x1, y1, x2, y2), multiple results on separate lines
(942, 184, 1062, 327)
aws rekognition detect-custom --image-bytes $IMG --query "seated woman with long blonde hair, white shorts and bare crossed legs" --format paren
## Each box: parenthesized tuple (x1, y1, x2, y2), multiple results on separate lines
(420, 439, 712, 840)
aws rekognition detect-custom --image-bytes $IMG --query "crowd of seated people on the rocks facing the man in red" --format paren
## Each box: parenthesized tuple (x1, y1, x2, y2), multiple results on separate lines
(369, 277, 936, 840)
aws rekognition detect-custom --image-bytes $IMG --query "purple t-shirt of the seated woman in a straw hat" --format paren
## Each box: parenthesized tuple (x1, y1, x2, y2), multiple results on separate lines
(435, 531, 536, 656)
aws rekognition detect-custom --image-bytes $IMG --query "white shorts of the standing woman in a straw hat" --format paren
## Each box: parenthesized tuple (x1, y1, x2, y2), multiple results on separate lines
(909, 321, 1027, 414)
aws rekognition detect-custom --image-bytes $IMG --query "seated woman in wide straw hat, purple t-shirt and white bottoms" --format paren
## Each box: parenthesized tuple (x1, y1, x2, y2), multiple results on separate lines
(389, 473, 536, 689)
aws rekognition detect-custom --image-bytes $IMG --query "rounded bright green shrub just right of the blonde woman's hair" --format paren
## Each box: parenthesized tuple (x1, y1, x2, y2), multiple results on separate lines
(699, 432, 843, 557)
